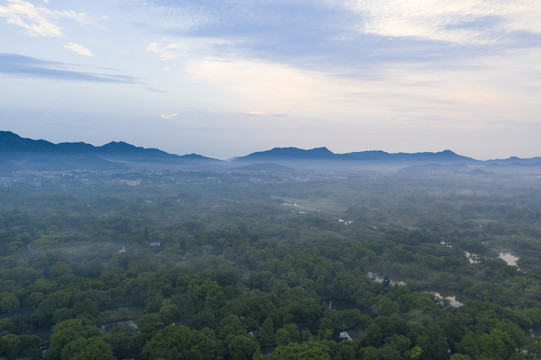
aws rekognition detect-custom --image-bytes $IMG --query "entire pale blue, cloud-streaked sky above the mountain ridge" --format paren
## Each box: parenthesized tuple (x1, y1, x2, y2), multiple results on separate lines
(0, 0, 541, 160)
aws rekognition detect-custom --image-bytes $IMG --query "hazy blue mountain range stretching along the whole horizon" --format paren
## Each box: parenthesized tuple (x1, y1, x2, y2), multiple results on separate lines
(0, 131, 541, 173)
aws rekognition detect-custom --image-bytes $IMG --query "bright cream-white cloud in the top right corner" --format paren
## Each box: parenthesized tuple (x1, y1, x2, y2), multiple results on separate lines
(346, 0, 541, 44)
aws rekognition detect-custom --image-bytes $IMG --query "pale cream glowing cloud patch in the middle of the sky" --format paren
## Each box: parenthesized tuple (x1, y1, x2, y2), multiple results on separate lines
(186, 59, 375, 119)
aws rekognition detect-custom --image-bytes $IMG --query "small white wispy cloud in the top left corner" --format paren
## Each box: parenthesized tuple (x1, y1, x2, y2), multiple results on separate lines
(0, 0, 86, 37)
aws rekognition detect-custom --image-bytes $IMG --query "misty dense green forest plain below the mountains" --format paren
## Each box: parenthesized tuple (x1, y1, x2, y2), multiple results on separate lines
(0, 171, 541, 360)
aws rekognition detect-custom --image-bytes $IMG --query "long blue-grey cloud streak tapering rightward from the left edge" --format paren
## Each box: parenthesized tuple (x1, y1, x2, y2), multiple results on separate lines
(0, 53, 138, 84)
